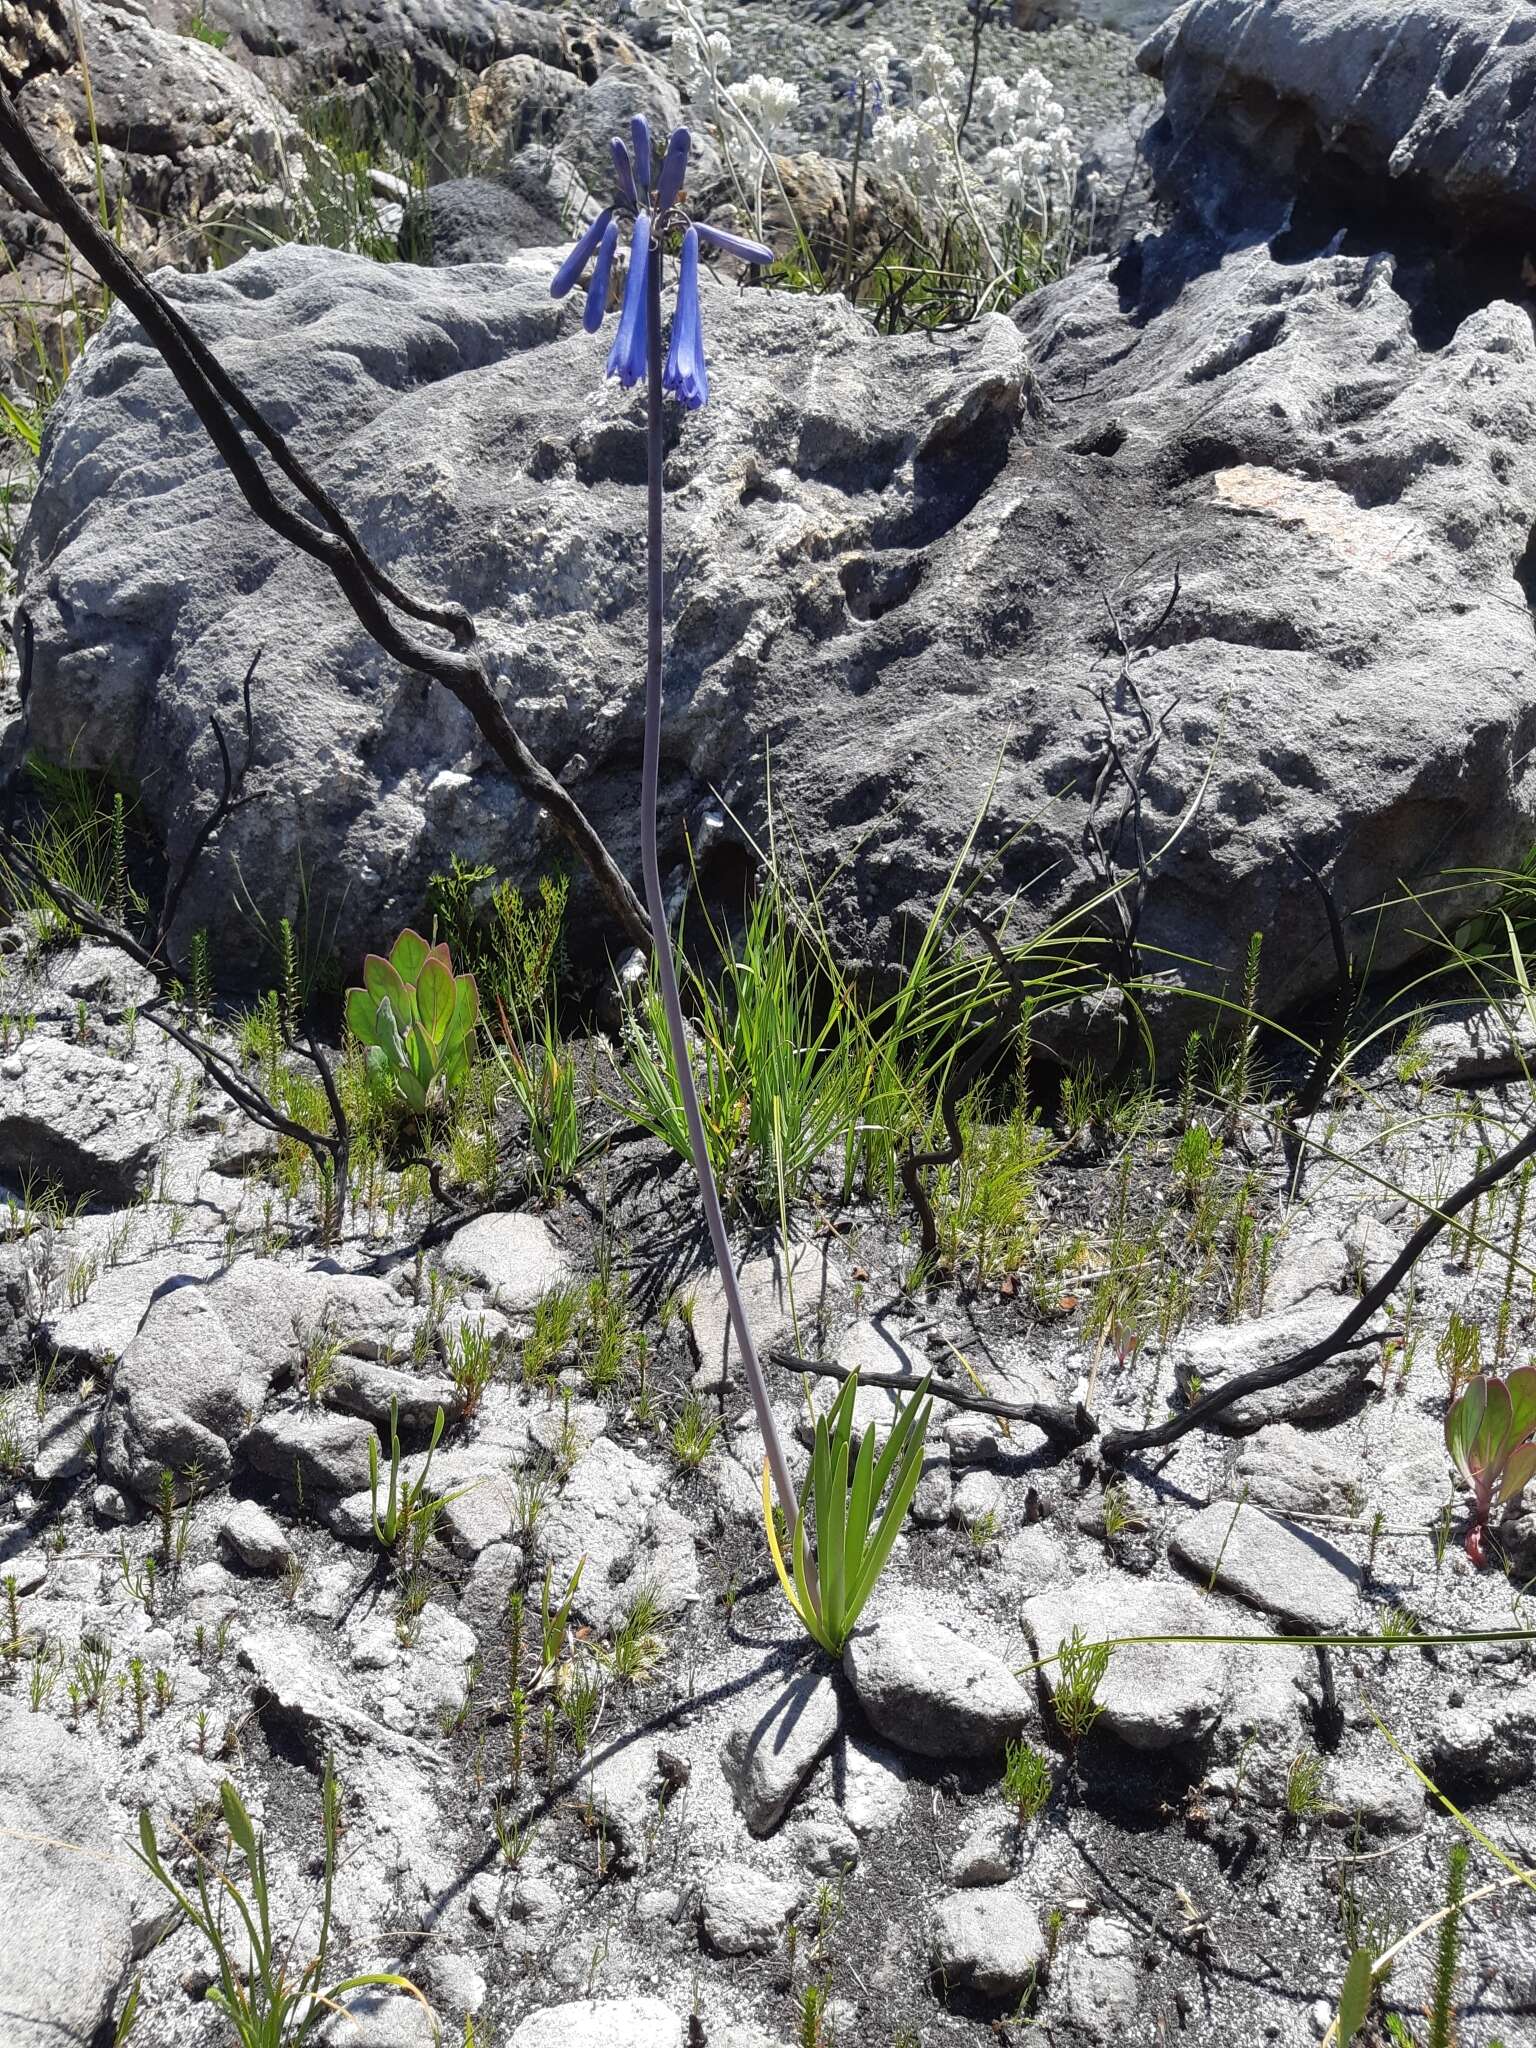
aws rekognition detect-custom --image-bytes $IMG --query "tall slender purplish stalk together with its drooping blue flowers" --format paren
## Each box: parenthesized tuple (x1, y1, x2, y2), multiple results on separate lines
(551, 117, 815, 1556)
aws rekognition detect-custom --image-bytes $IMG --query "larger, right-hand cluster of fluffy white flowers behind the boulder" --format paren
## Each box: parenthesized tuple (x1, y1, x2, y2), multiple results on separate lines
(860, 39, 1079, 219)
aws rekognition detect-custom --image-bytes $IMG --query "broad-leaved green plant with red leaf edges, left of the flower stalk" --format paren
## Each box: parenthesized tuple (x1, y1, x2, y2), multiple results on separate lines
(346, 932, 479, 1116)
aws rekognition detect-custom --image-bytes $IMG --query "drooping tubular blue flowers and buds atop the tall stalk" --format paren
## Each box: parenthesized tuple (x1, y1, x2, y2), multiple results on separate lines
(549, 115, 774, 412)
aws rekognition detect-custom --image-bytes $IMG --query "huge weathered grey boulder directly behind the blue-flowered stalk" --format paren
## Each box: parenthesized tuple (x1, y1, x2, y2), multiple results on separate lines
(18, 186, 1536, 1008)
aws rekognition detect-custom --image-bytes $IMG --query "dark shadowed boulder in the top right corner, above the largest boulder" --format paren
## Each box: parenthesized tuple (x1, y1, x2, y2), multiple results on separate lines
(1139, 0, 1536, 237)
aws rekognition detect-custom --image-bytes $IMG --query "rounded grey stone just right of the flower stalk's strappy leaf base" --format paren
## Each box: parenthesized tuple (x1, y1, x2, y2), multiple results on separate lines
(844, 1614, 1032, 1757)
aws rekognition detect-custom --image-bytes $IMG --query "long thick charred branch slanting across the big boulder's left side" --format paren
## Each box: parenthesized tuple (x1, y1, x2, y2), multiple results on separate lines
(0, 90, 651, 952)
